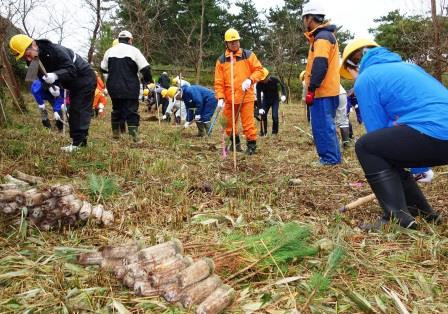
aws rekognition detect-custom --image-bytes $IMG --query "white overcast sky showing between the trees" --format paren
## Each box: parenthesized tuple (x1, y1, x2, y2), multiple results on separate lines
(16, 0, 430, 56)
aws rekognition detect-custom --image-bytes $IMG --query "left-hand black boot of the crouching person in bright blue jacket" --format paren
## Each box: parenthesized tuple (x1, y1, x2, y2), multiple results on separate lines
(366, 169, 418, 229)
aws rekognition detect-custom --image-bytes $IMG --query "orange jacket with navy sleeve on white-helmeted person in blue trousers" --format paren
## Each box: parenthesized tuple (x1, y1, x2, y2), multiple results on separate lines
(305, 24, 340, 98)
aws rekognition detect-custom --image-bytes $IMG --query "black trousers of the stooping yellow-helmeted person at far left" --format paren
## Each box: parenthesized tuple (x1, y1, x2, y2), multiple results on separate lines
(68, 71, 96, 146)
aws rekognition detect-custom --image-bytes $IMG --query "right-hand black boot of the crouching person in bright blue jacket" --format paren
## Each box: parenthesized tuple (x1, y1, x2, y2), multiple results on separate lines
(400, 170, 442, 224)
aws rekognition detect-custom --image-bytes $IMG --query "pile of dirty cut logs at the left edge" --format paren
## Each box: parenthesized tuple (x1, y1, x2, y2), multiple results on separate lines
(0, 170, 114, 230)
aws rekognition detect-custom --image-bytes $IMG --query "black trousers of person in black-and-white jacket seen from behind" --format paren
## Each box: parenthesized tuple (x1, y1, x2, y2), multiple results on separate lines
(111, 98, 140, 126)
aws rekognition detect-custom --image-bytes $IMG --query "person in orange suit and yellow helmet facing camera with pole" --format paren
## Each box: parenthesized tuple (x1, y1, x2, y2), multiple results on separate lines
(215, 28, 263, 155)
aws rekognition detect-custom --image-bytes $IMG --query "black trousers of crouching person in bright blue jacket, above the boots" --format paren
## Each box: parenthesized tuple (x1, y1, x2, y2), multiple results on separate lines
(355, 125, 448, 174)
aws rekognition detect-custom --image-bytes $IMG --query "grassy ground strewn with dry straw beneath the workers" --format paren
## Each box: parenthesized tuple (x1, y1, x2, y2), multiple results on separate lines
(0, 98, 448, 313)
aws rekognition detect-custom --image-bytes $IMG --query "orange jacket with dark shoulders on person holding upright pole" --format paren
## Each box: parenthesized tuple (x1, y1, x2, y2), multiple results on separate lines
(215, 48, 263, 104)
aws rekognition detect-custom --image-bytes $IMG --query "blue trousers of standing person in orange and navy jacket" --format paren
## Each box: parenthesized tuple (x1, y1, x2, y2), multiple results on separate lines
(310, 96, 341, 165)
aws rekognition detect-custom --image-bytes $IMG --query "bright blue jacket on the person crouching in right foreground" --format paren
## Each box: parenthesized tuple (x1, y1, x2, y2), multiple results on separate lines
(355, 47, 448, 140)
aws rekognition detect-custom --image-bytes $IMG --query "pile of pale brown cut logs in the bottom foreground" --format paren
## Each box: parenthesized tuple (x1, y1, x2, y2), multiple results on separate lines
(77, 239, 235, 314)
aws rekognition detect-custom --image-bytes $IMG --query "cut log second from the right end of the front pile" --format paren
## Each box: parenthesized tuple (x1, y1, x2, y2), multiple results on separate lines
(180, 275, 222, 309)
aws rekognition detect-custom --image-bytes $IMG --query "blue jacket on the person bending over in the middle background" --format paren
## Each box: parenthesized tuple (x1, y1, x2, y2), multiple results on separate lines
(182, 85, 218, 122)
